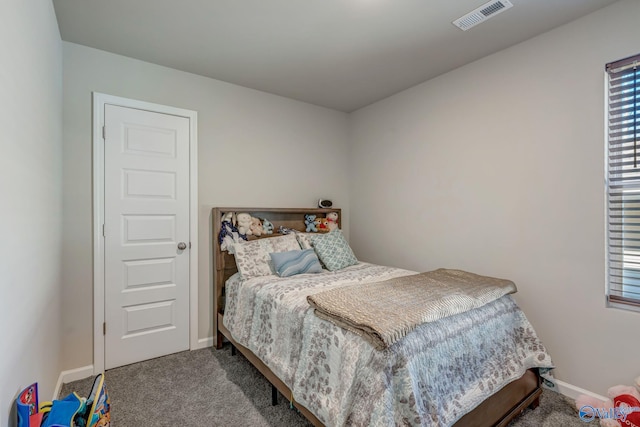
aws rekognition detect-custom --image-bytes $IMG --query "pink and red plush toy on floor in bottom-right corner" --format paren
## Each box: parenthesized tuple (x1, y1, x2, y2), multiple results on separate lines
(576, 377, 640, 427)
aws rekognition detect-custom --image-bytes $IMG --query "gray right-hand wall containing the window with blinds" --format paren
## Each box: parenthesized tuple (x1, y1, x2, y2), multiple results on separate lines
(349, 0, 640, 395)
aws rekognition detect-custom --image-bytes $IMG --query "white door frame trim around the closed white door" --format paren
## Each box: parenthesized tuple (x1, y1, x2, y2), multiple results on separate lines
(93, 92, 198, 375)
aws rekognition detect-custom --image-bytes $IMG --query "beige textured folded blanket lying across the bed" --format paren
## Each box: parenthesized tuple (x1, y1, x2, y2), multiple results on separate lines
(307, 268, 517, 350)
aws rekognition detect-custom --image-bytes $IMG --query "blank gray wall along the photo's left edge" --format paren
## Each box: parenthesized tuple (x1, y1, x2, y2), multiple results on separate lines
(0, 0, 62, 425)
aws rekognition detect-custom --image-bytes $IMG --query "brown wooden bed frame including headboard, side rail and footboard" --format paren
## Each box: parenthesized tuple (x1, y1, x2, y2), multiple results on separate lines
(211, 208, 542, 427)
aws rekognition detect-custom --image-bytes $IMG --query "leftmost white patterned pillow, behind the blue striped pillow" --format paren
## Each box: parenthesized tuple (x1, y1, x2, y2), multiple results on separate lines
(233, 234, 300, 280)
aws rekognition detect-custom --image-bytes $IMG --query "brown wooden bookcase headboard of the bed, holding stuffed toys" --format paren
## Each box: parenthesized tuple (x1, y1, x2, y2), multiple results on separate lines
(211, 208, 342, 348)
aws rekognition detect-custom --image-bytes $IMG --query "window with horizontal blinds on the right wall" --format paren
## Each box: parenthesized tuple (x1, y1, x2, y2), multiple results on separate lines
(606, 55, 640, 308)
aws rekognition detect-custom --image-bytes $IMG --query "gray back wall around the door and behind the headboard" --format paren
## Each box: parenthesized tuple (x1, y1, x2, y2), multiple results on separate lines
(63, 42, 349, 369)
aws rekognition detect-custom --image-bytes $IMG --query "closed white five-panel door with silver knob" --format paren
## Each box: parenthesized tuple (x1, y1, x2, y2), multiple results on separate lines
(104, 104, 189, 369)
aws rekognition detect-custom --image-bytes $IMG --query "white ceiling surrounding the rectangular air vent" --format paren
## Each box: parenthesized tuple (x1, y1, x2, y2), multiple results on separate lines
(53, 0, 616, 112)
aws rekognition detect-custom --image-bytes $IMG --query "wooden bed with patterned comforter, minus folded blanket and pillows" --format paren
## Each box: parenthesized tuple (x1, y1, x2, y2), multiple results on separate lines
(212, 208, 552, 426)
